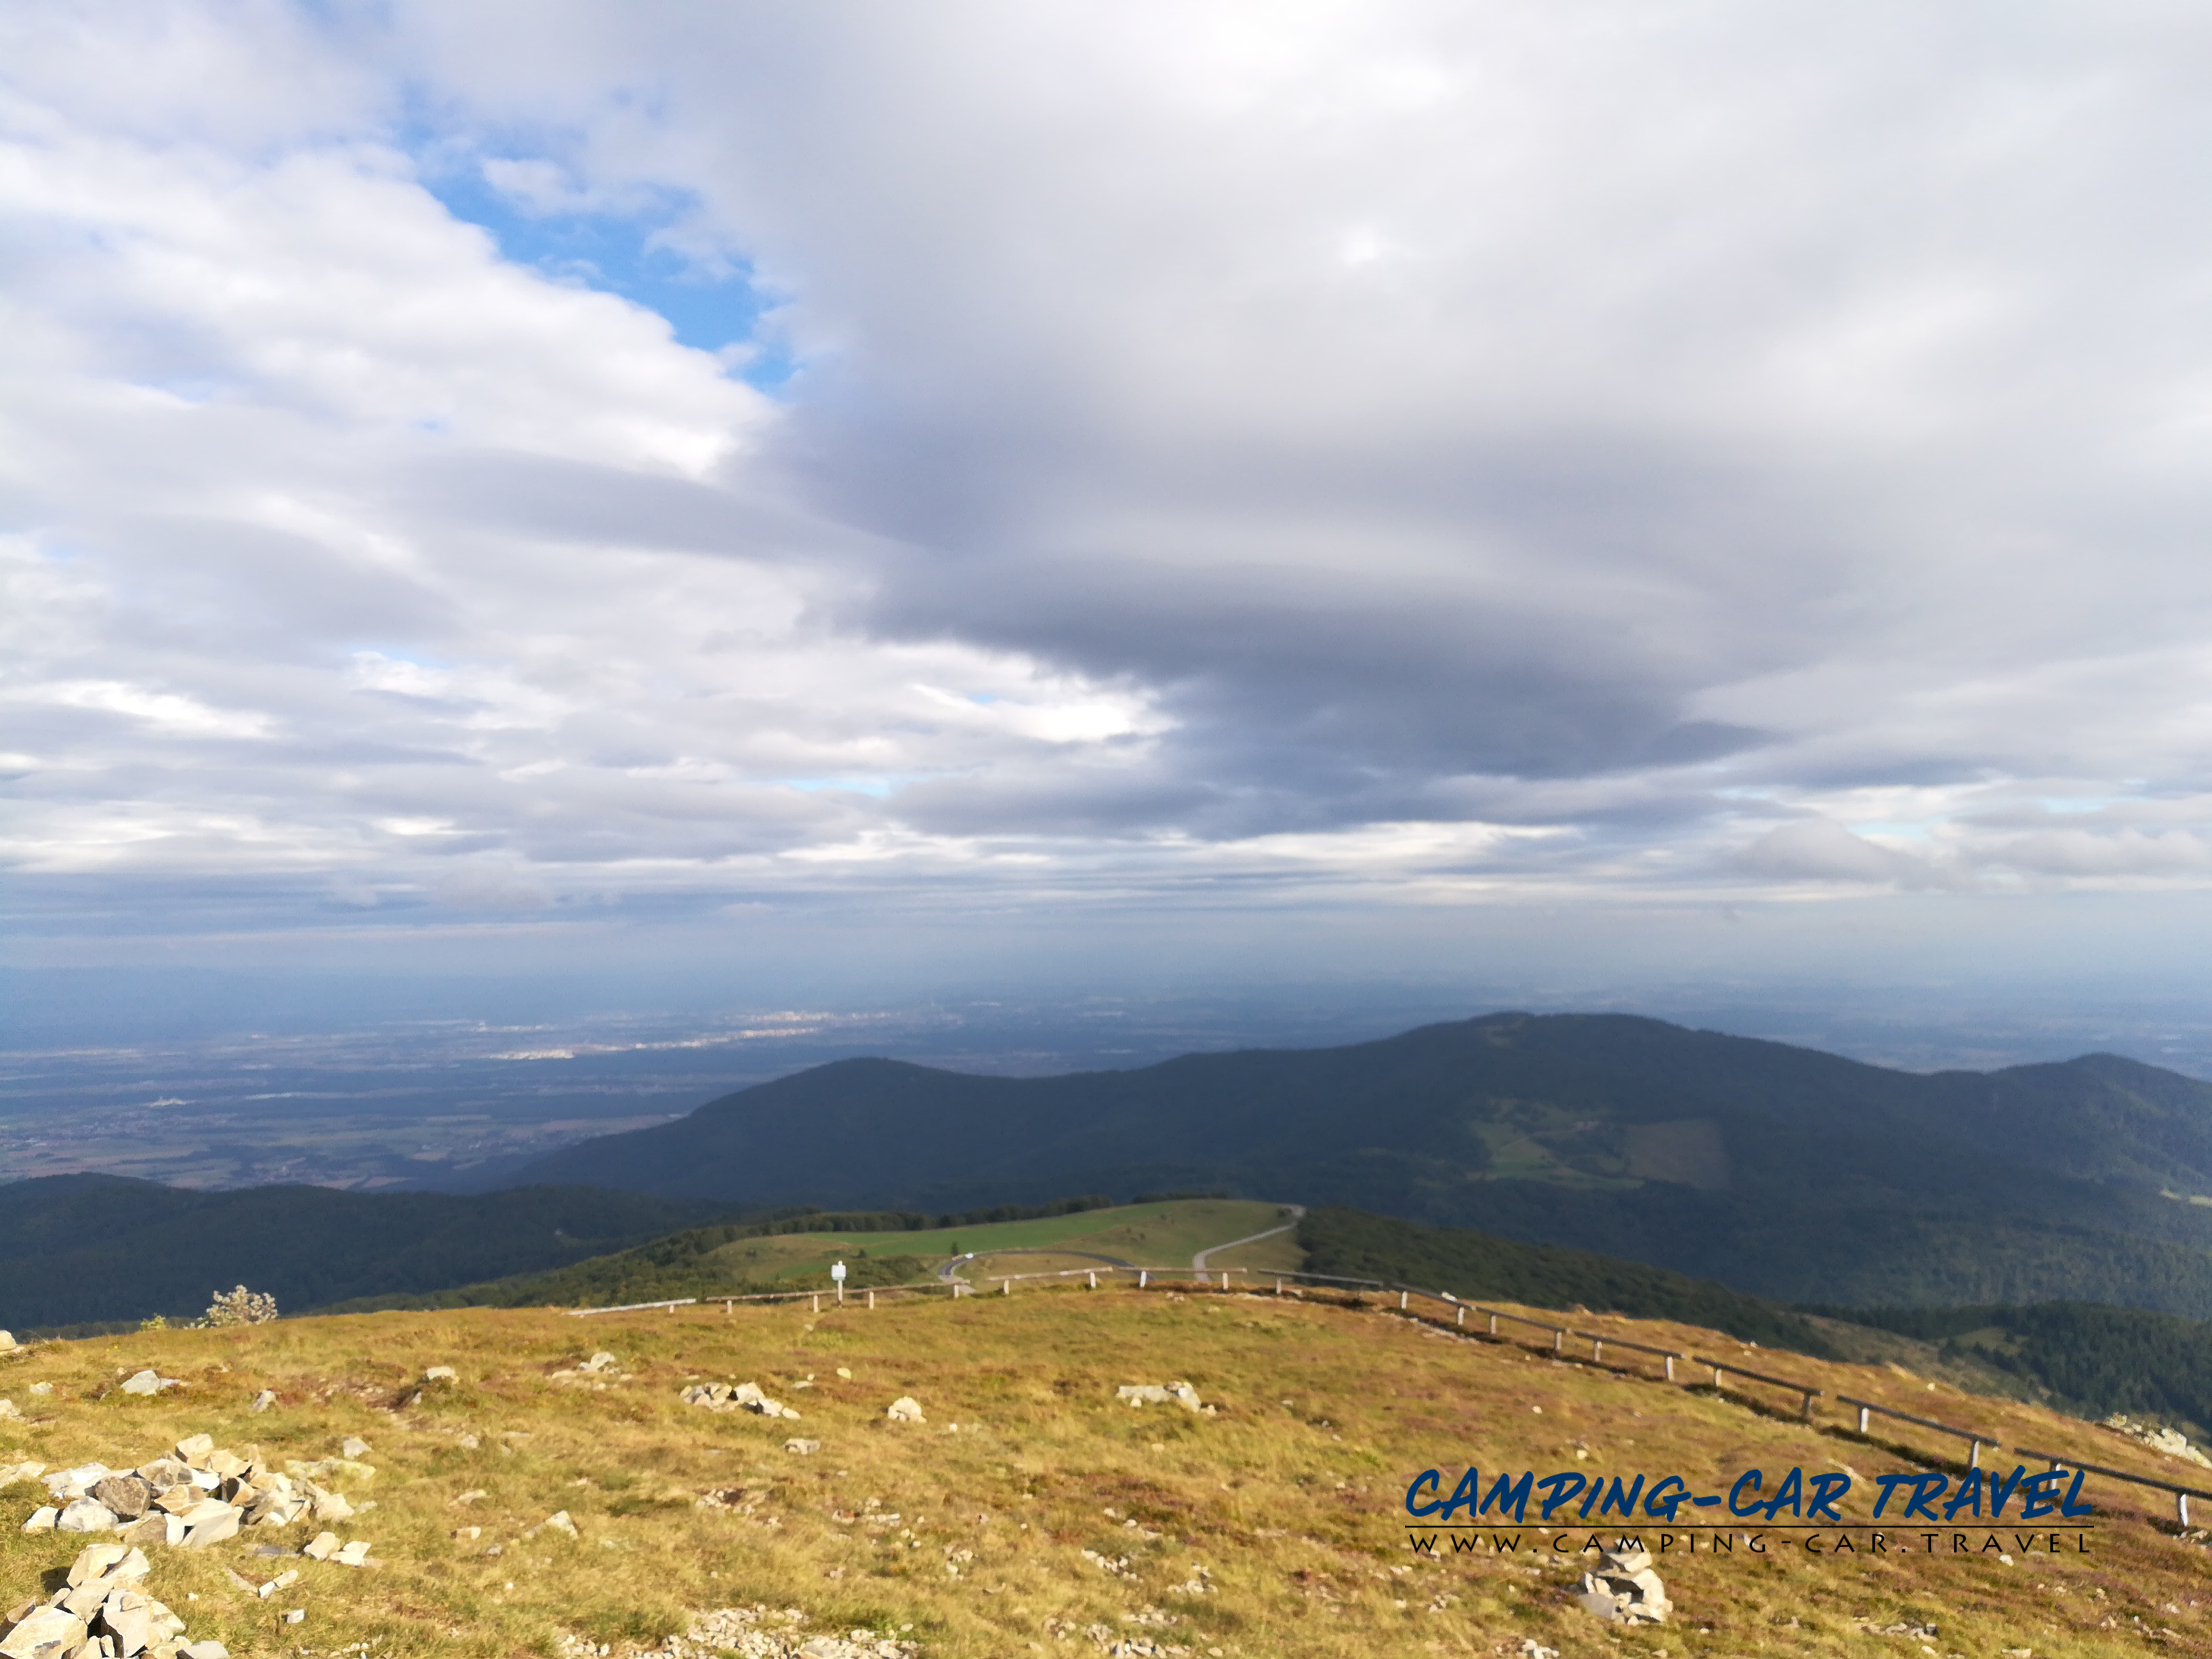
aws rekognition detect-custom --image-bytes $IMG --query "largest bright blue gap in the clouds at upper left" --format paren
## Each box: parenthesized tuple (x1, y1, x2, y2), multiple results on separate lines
(409, 146, 798, 394)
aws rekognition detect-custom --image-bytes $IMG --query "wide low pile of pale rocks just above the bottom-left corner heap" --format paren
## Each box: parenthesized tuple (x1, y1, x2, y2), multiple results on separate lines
(17, 1433, 358, 1549)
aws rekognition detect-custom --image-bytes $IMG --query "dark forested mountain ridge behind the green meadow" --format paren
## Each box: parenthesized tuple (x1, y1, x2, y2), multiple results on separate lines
(493, 1013, 2212, 1318)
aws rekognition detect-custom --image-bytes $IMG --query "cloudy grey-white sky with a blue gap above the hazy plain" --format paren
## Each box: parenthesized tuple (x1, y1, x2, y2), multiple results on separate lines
(0, 0, 2212, 1052)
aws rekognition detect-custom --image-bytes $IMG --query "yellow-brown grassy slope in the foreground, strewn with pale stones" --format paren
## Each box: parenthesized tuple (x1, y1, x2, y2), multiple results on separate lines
(0, 1290, 2212, 1659)
